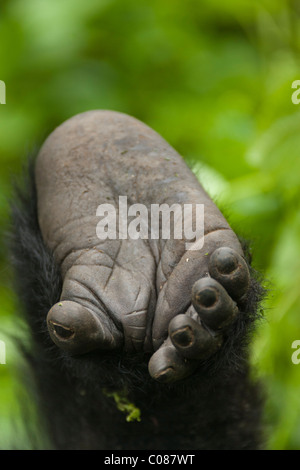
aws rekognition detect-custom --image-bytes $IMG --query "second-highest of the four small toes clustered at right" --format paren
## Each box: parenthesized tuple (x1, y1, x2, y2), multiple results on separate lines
(192, 277, 238, 330)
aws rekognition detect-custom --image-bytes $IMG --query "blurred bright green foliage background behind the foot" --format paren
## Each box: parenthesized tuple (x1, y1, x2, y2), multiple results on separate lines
(0, 0, 300, 449)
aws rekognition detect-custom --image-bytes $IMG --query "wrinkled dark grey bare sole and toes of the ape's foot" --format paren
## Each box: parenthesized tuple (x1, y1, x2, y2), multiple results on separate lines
(36, 111, 249, 382)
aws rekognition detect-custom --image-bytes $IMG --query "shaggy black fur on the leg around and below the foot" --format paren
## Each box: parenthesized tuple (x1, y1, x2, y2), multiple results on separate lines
(11, 160, 263, 450)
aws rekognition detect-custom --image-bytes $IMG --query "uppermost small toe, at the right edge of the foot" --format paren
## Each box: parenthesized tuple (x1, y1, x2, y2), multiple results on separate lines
(209, 247, 250, 300)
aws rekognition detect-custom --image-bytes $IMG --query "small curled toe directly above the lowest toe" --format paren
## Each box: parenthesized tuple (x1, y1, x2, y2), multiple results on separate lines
(169, 314, 222, 360)
